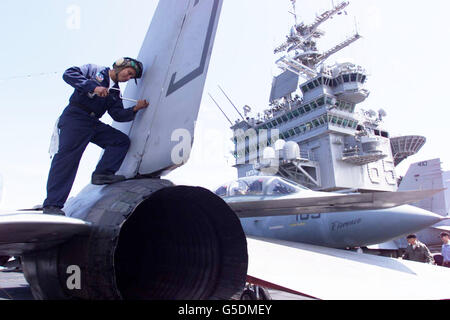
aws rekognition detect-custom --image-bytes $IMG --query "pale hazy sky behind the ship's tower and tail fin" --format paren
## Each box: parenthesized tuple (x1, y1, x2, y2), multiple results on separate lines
(0, 0, 450, 209)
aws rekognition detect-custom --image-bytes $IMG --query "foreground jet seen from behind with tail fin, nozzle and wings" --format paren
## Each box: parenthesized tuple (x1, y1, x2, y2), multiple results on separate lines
(0, 0, 450, 299)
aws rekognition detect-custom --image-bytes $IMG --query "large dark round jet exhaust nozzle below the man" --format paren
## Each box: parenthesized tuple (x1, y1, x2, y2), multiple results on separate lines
(24, 179, 248, 300)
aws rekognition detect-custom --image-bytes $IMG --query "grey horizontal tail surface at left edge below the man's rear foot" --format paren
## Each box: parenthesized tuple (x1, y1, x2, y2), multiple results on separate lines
(0, 212, 91, 256)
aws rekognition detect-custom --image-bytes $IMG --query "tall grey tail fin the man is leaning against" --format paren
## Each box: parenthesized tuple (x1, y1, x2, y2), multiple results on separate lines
(114, 0, 223, 178)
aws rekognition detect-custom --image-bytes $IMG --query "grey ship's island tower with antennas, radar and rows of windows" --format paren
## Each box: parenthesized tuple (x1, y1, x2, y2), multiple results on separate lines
(231, 0, 425, 191)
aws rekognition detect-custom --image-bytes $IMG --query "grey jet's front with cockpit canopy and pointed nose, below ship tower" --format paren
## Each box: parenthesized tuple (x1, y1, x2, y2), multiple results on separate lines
(216, 176, 442, 248)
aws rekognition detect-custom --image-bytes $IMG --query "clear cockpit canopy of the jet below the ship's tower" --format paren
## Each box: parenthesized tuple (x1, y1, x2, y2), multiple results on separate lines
(215, 176, 308, 197)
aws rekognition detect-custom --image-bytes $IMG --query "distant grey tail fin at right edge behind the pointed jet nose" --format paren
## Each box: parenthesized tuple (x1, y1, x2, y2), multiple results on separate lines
(399, 159, 450, 216)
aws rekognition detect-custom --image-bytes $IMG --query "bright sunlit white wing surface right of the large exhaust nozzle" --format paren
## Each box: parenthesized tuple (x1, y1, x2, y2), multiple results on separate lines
(247, 237, 450, 300)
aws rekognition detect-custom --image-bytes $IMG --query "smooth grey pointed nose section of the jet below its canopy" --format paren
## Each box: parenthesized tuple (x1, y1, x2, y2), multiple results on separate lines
(240, 205, 440, 248)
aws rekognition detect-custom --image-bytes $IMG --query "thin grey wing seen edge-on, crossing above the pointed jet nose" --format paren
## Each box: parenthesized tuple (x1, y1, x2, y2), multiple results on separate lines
(227, 189, 443, 218)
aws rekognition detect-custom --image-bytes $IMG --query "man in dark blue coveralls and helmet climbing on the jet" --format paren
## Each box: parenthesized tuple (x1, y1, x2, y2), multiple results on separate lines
(44, 58, 148, 215)
